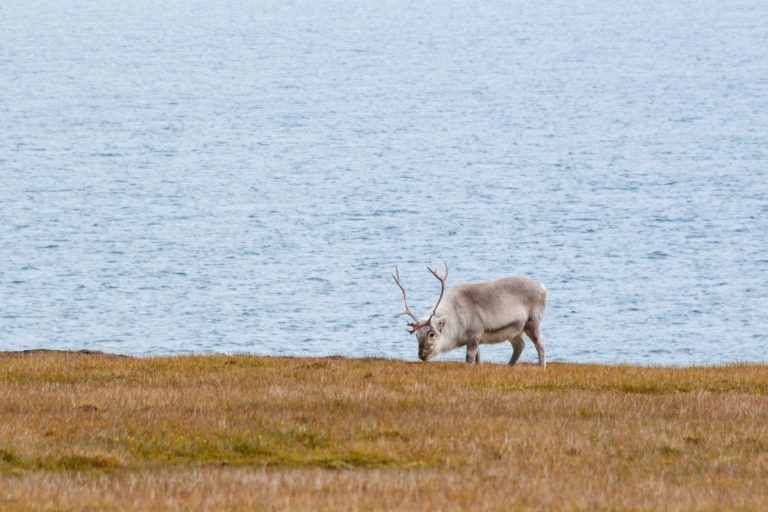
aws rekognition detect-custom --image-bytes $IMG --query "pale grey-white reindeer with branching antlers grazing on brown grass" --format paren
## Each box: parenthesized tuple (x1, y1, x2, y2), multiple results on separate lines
(392, 263, 547, 368)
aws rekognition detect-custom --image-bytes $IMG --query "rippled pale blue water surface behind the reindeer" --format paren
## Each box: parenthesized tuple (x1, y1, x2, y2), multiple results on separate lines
(0, 0, 768, 365)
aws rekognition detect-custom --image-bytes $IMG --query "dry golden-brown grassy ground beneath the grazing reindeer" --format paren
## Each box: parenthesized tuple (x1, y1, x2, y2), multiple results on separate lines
(0, 353, 768, 510)
